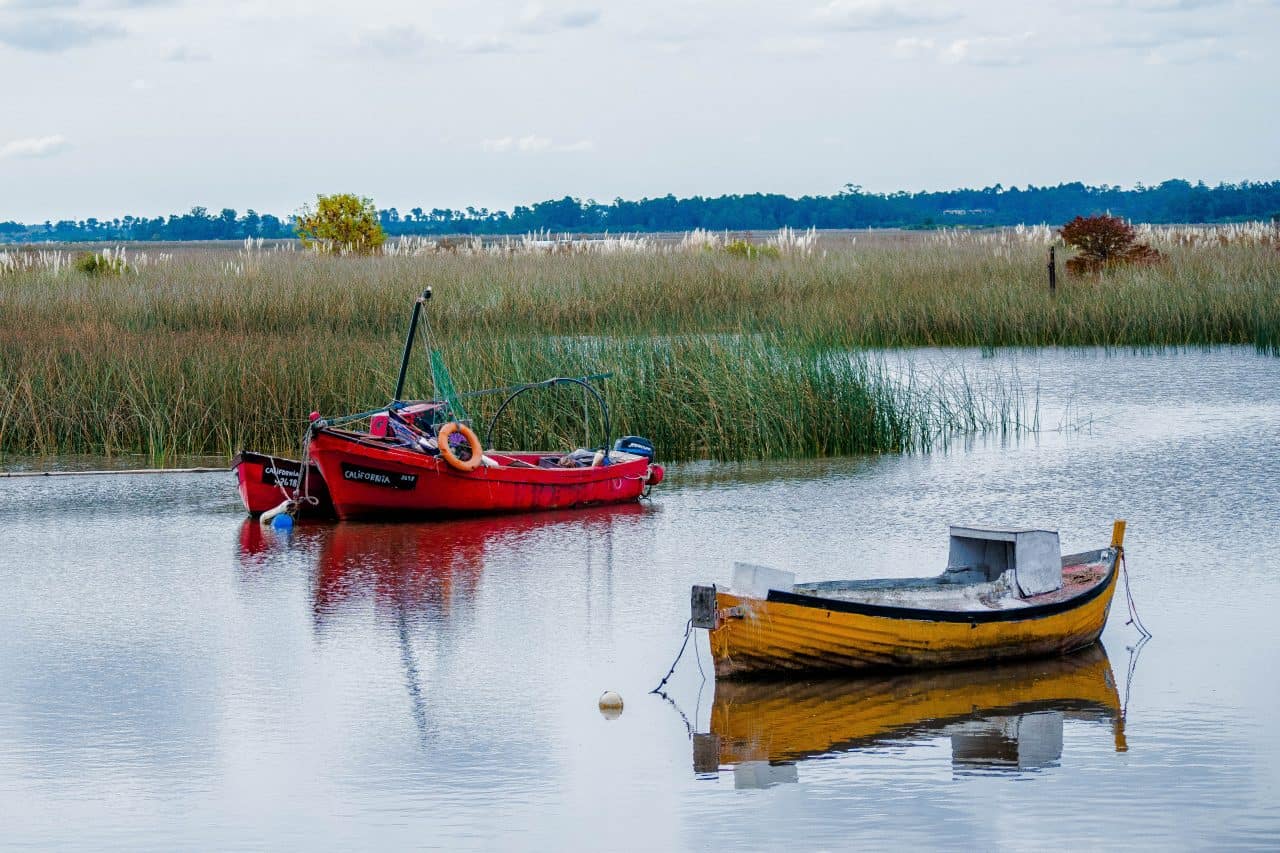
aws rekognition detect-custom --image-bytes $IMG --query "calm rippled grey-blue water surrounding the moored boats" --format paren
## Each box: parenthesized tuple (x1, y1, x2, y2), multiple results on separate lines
(0, 350, 1280, 849)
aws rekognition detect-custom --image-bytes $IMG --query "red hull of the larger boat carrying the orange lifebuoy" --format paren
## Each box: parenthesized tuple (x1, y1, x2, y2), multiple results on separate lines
(311, 429, 658, 519)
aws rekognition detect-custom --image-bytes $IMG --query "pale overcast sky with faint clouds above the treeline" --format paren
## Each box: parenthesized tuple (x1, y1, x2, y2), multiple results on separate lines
(0, 0, 1280, 222)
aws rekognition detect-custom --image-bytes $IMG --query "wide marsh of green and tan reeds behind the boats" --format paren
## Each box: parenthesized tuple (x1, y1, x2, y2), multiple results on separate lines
(0, 224, 1280, 462)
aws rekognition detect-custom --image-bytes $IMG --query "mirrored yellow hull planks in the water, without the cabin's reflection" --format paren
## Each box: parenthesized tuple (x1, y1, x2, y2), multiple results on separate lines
(695, 644, 1126, 772)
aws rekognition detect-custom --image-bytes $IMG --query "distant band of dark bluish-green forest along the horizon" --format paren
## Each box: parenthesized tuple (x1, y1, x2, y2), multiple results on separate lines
(0, 181, 1280, 243)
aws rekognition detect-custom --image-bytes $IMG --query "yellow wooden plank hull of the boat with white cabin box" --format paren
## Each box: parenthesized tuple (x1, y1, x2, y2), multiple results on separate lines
(709, 548, 1120, 678)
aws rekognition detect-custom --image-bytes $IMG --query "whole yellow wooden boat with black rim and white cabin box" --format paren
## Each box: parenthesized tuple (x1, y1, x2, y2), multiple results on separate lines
(691, 521, 1125, 678)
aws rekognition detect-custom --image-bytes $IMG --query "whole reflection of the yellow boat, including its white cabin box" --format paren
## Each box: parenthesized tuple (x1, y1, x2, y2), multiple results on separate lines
(694, 643, 1126, 788)
